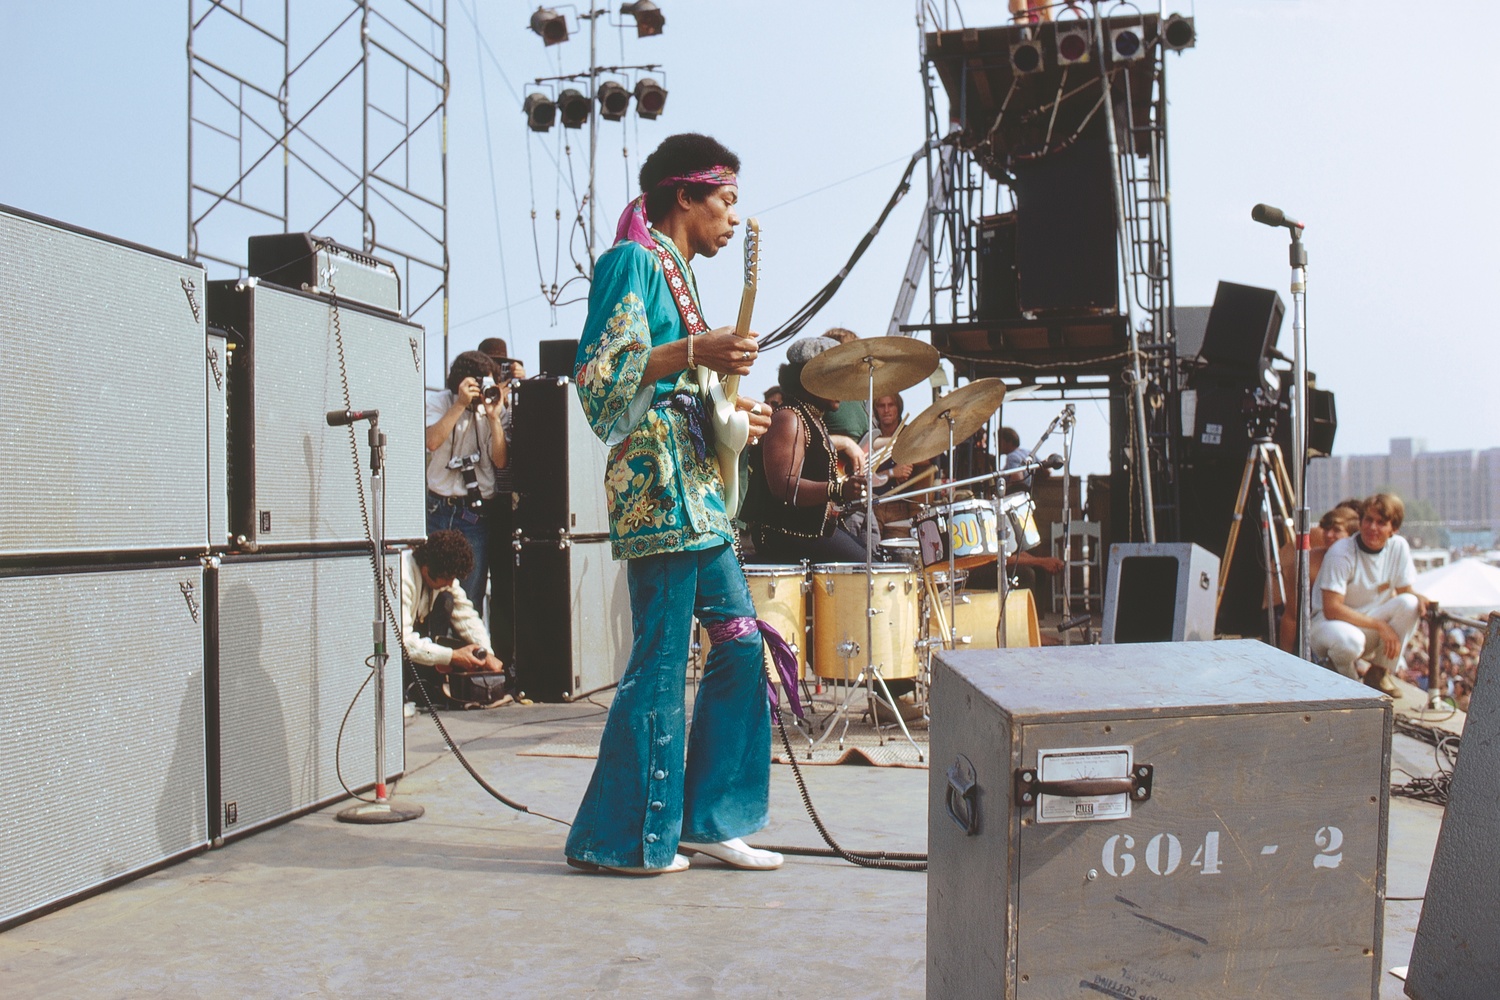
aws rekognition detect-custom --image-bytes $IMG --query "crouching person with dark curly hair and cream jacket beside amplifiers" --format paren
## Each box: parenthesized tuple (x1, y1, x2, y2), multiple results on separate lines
(401, 531, 504, 703)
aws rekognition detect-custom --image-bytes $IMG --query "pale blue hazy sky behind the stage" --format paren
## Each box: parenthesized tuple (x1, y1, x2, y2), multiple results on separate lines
(0, 0, 1500, 471)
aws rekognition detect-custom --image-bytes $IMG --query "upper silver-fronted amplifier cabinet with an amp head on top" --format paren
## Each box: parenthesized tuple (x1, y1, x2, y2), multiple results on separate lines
(209, 280, 428, 552)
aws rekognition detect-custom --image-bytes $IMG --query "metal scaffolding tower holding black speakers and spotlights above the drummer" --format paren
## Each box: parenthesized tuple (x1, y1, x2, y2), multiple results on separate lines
(902, 3, 1194, 540)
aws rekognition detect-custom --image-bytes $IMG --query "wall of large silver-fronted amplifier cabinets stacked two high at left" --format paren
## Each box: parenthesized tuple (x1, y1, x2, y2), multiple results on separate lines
(0, 205, 425, 928)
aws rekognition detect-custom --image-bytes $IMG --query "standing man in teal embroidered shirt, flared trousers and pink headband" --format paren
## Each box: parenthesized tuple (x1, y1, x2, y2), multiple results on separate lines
(567, 133, 782, 874)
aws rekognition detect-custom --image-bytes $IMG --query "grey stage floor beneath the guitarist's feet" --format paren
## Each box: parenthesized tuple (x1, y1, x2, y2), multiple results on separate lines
(0, 668, 1442, 1000)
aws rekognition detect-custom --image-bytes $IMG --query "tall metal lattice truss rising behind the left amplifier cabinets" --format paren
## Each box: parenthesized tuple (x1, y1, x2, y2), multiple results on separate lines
(188, 0, 449, 370)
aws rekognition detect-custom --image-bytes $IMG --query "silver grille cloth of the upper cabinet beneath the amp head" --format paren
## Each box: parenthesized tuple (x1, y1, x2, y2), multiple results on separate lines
(252, 285, 426, 546)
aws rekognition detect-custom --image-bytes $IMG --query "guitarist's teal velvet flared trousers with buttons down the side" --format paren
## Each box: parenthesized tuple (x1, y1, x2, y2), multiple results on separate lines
(567, 544, 771, 868)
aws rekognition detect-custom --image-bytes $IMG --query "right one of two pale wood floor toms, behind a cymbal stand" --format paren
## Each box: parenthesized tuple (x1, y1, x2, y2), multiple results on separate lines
(813, 562, 920, 681)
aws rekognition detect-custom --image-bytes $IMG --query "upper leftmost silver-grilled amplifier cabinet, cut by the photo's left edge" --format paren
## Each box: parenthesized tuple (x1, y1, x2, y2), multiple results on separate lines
(0, 205, 210, 558)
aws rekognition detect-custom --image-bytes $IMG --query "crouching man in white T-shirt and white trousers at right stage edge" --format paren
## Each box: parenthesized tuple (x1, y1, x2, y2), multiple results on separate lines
(1308, 493, 1427, 694)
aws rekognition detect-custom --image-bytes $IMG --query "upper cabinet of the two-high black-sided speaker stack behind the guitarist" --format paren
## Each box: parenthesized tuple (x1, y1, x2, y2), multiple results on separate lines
(510, 376, 609, 541)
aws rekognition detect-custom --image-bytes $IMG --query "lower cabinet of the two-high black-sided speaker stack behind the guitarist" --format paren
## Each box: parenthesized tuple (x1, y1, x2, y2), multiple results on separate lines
(516, 538, 632, 702)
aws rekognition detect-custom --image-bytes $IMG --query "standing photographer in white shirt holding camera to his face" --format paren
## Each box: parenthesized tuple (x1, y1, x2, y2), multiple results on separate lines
(428, 351, 510, 616)
